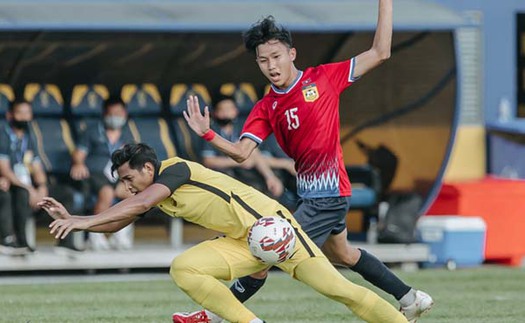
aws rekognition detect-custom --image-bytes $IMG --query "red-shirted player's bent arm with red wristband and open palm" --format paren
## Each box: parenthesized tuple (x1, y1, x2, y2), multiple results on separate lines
(183, 95, 257, 163)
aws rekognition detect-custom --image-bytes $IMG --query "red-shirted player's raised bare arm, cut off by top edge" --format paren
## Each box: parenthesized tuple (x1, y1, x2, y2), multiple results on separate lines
(353, 0, 393, 77)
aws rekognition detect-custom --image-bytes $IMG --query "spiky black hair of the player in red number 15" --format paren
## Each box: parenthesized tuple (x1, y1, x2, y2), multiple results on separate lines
(242, 16, 293, 53)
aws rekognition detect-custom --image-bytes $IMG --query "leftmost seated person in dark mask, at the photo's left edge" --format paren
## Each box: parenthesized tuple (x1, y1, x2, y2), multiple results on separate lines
(0, 100, 77, 251)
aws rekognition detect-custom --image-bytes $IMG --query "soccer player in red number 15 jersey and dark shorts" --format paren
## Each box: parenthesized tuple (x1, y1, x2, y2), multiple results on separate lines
(180, 0, 433, 322)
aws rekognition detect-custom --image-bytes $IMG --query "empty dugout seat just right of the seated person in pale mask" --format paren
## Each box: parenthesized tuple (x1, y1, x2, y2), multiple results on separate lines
(121, 83, 177, 160)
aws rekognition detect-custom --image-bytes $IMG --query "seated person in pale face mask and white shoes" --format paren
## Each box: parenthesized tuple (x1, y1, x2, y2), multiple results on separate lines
(70, 97, 134, 250)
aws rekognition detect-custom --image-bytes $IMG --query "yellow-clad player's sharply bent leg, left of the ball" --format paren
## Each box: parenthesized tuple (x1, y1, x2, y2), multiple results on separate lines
(170, 238, 265, 322)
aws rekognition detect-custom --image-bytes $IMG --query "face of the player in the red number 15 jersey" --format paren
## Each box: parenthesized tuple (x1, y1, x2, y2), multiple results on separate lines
(257, 40, 297, 89)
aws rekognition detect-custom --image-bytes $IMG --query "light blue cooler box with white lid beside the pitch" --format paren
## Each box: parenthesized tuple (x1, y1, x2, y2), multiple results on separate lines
(417, 216, 486, 269)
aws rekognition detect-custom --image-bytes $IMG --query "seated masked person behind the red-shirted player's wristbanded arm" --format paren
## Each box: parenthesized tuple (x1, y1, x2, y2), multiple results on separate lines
(201, 95, 283, 197)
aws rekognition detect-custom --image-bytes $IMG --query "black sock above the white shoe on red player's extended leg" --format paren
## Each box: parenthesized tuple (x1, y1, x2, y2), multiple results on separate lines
(350, 249, 411, 300)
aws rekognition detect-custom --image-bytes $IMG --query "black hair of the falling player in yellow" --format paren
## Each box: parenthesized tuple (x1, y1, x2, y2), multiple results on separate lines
(111, 143, 159, 173)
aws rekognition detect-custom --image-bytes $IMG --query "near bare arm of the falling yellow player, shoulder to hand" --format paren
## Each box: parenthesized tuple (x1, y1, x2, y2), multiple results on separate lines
(49, 184, 171, 239)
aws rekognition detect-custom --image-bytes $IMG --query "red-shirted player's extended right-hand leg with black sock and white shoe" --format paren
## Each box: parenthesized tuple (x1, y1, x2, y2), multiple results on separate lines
(322, 222, 433, 319)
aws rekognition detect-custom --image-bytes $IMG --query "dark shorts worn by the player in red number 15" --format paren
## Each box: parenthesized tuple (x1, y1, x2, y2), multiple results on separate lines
(294, 196, 350, 248)
